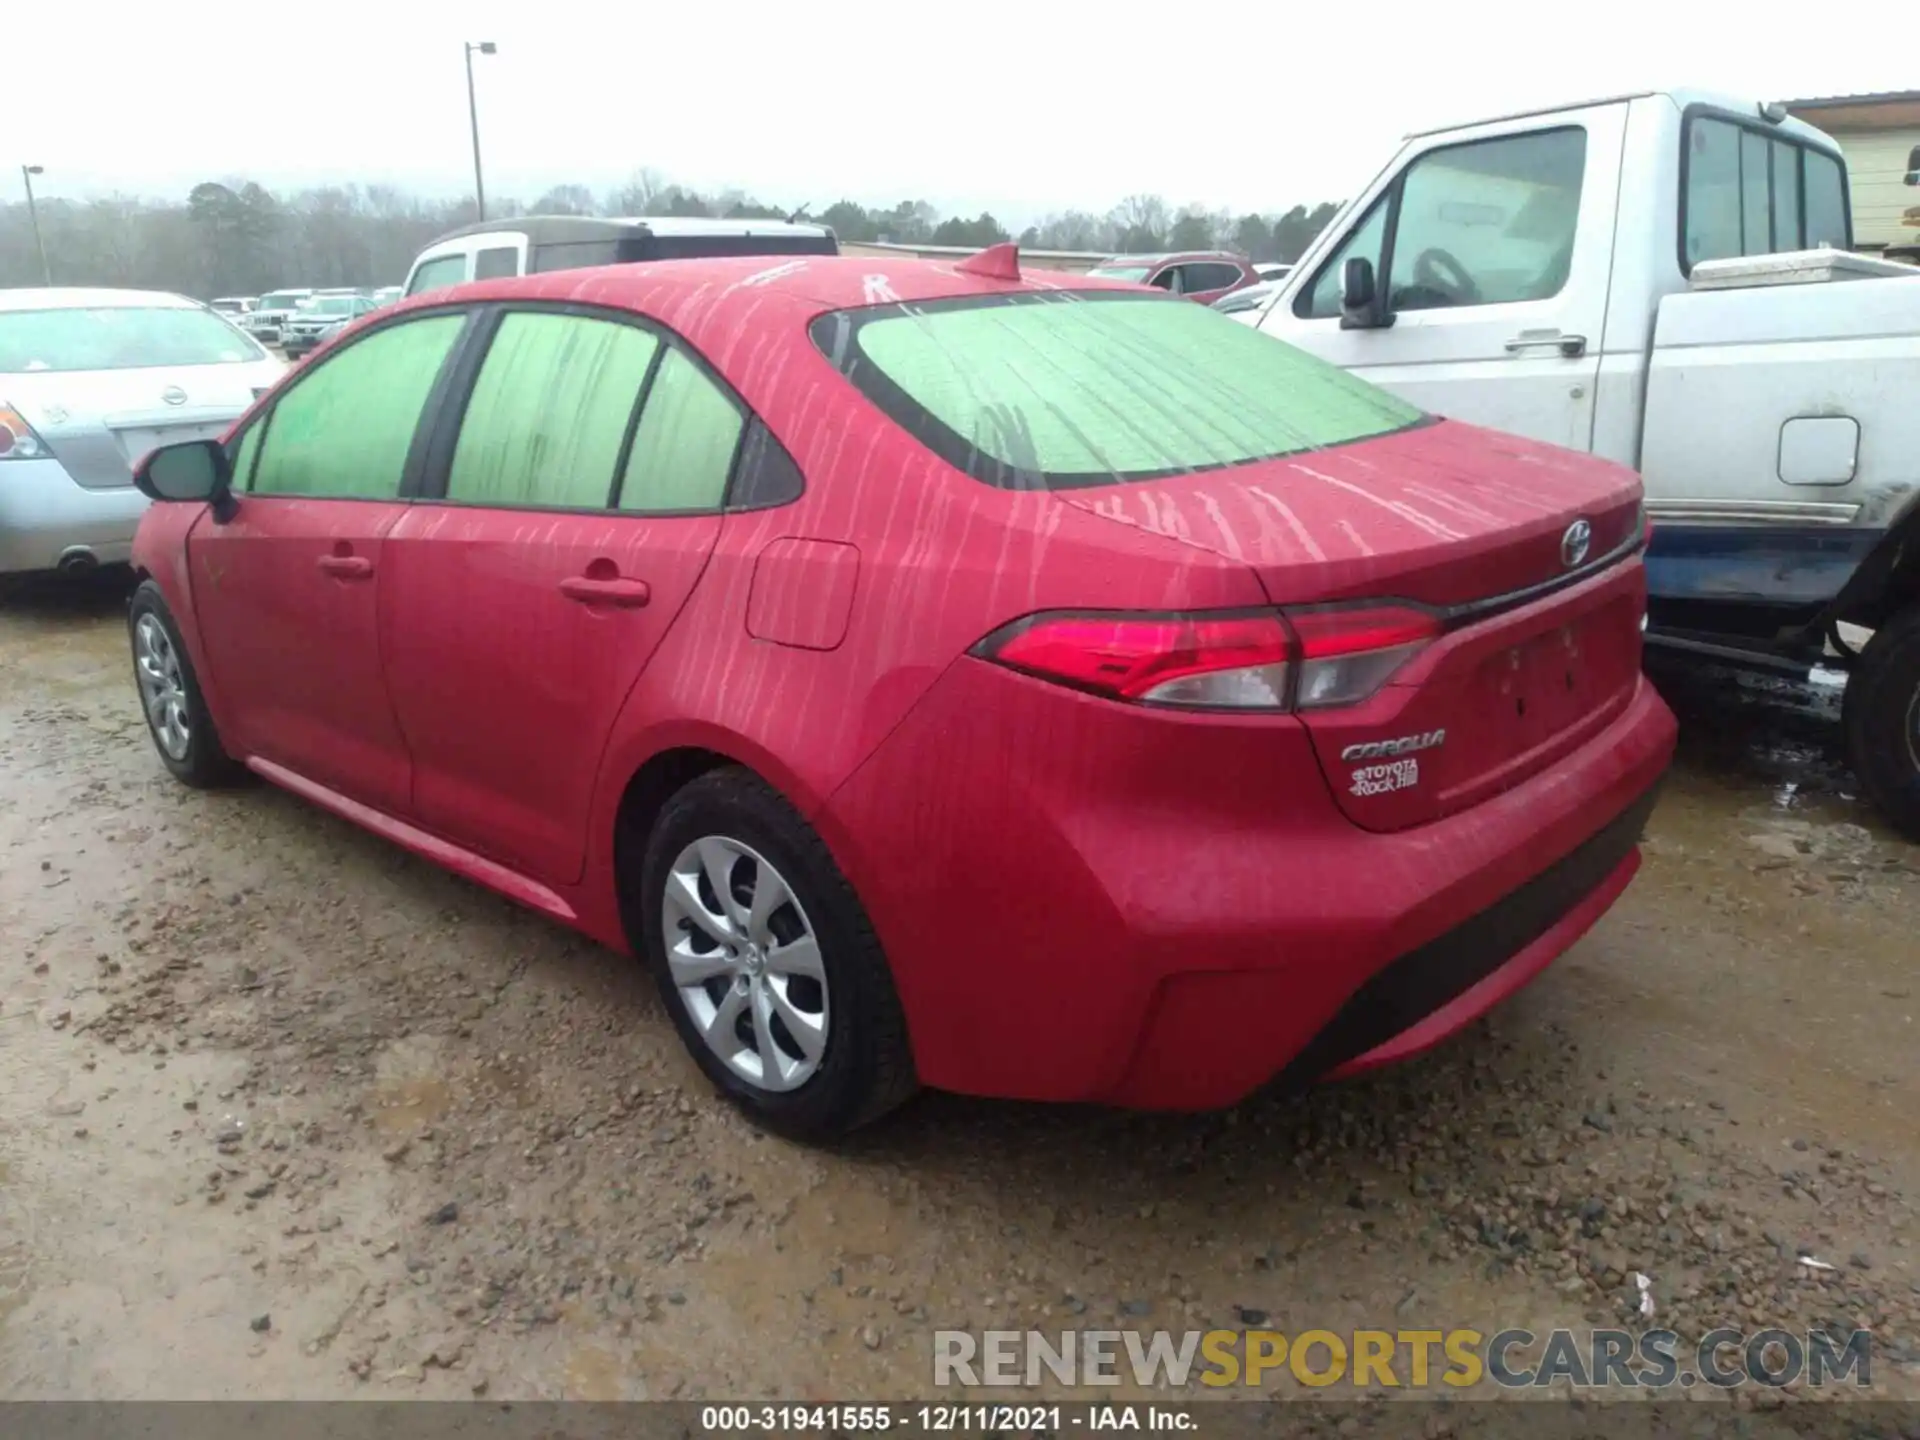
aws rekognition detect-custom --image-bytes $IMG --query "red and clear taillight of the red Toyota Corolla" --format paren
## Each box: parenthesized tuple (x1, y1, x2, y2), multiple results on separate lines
(973, 605, 1440, 710)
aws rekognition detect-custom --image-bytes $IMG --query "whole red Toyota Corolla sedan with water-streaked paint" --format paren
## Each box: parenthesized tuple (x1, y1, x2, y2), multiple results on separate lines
(131, 248, 1674, 1137)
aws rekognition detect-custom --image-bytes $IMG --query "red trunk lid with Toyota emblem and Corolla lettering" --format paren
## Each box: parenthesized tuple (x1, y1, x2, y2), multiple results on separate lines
(1058, 420, 1645, 831)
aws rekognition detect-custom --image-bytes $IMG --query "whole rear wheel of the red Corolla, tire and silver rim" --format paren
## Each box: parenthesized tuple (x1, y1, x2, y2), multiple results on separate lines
(637, 768, 916, 1140)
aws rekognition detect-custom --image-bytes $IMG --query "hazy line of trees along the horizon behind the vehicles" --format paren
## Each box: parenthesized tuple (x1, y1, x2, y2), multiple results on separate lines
(0, 171, 1334, 300)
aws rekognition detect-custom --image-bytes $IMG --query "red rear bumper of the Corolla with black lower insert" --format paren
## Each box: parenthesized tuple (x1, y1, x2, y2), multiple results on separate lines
(820, 660, 1676, 1110)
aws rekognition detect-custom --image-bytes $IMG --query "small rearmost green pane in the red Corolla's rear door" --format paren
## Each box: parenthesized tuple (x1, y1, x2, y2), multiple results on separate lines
(618, 349, 745, 511)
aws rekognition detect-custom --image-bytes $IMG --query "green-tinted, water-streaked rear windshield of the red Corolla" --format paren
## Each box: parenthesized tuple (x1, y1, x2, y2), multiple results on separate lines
(812, 290, 1425, 490)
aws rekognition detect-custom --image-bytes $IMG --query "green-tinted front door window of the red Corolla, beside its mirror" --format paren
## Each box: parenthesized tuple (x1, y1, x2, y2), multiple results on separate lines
(247, 315, 467, 499)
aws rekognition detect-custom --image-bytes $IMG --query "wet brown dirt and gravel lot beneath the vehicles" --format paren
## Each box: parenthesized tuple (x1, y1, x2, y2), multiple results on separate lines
(0, 591, 1920, 1400)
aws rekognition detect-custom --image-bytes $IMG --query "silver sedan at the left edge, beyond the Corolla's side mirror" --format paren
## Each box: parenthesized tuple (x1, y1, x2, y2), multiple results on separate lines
(0, 288, 286, 576)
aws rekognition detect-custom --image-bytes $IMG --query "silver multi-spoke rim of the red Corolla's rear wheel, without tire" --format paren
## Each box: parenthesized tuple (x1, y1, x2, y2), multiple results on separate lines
(660, 835, 829, 1091)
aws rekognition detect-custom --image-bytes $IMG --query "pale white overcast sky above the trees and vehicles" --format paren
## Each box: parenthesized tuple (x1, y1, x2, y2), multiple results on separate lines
(0, 0, 1914, 228)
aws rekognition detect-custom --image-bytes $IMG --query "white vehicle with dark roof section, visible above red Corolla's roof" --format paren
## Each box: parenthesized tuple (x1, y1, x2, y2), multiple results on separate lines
(407, 215, 839, 296)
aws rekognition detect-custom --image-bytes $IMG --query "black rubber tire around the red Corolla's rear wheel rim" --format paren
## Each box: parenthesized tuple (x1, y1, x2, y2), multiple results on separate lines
(637, 766, 918, 1142)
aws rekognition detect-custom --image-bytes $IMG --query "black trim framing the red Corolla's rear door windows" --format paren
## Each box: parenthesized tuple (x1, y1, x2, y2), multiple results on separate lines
(409, 300, 791, 520)
